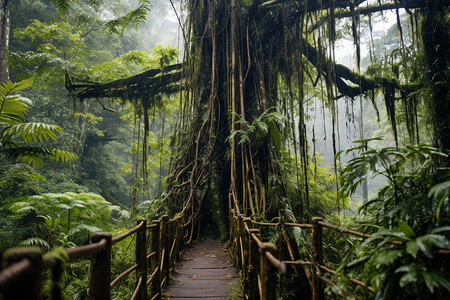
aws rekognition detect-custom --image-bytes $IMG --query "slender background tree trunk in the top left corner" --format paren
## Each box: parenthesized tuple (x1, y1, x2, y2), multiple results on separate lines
(0, 0, 11, 82)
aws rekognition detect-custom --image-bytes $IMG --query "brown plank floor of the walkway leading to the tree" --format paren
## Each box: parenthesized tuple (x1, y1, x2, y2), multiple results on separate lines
(163, 240, 240, 300)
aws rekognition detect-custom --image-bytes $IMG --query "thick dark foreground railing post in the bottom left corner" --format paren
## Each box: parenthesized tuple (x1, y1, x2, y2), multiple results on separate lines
(1, 247, 42, 300)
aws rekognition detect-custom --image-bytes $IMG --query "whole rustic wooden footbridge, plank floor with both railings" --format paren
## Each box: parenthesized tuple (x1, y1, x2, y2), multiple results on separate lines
(0, 197, 448, 300)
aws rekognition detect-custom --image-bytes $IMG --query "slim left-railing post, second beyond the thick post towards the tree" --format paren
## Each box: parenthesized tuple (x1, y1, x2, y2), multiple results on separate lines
(150, 220, 161, 300)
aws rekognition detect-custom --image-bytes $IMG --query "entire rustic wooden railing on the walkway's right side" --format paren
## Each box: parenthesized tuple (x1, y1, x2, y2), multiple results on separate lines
(230, 204, 450, 300)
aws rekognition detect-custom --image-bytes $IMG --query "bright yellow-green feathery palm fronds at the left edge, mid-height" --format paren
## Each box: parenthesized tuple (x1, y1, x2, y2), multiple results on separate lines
(0, 81, 77, 167)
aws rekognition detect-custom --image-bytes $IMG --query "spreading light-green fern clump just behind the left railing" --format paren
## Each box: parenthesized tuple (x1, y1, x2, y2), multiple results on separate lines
(5, 192, 130, 248)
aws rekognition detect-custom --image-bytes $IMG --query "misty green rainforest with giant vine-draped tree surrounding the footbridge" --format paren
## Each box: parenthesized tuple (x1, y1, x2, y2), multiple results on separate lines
(0, 0, 450, 299)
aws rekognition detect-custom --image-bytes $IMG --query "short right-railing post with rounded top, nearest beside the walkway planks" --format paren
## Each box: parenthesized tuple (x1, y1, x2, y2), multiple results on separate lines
(260, 243, 277, 300)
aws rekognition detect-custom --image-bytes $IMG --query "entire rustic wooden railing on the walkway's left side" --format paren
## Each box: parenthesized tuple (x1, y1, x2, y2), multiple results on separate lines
(0, 216, 185, 300)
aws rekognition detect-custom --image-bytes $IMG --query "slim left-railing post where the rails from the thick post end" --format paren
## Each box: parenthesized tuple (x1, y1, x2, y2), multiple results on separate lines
(136, 218, 148, 300)
